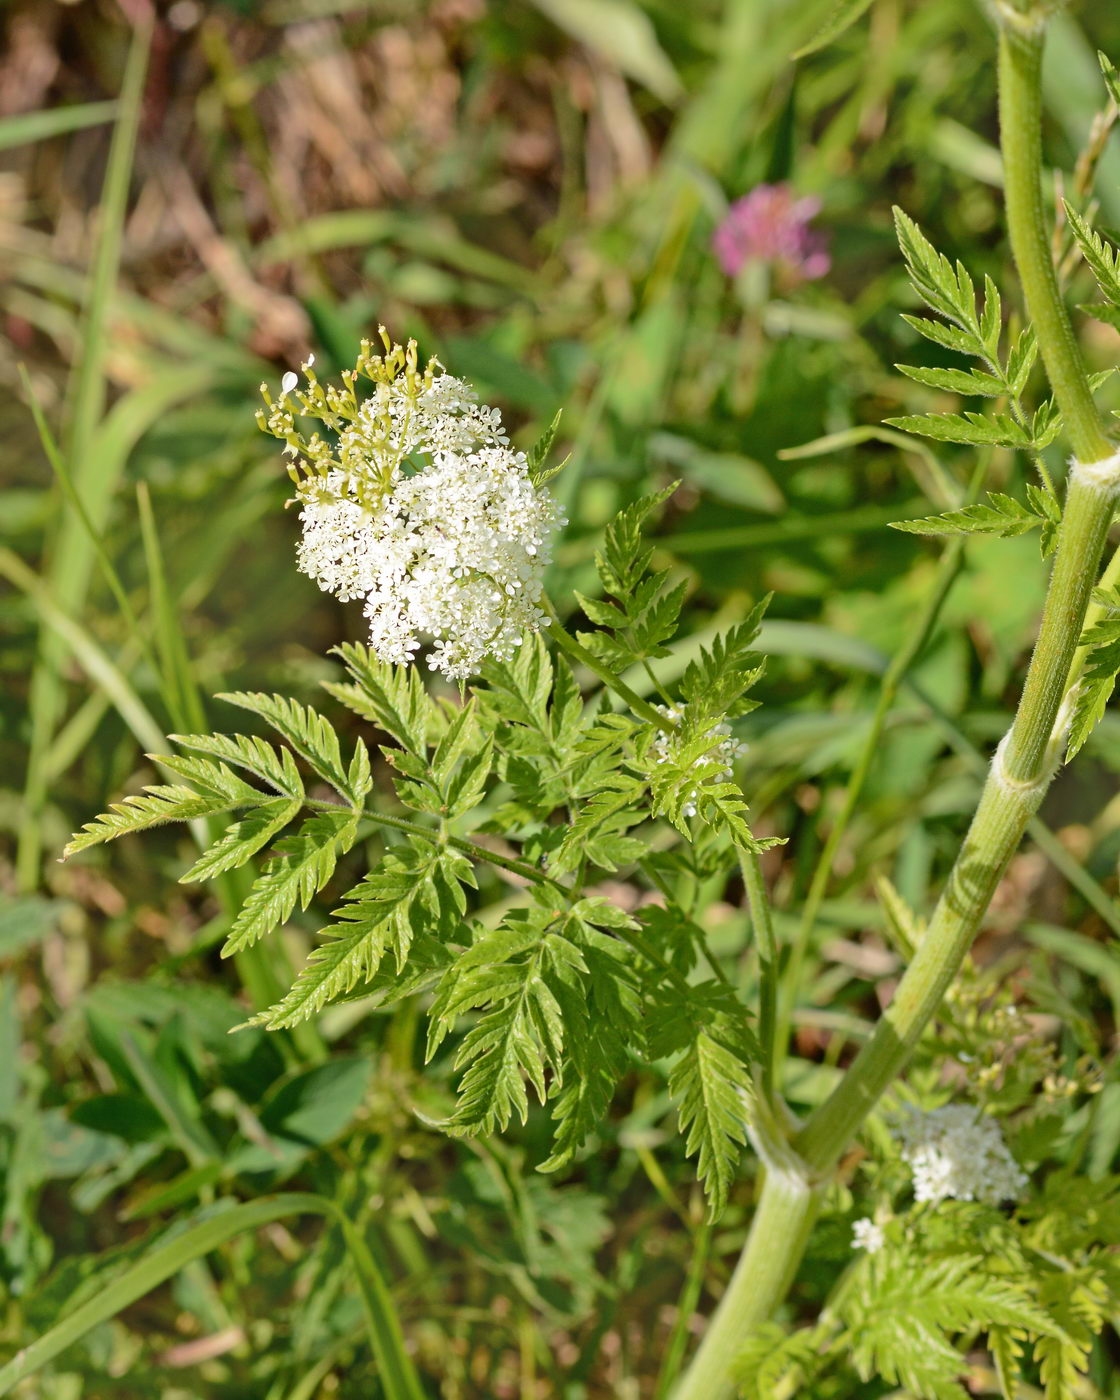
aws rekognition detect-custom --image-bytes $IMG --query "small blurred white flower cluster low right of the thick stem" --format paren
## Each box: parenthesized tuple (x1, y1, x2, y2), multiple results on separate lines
(895, 1103, 1026, 1205)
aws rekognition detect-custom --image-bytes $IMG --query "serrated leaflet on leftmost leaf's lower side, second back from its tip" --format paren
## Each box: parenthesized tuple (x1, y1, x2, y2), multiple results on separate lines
(223, 808, 358, 958)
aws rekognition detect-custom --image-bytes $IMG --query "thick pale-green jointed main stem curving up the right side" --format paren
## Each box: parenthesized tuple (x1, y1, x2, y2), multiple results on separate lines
(675, 10, 1120, 1400)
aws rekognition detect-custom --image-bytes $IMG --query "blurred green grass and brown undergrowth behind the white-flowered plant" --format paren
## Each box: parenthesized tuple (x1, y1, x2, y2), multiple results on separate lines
(0, 0, 1120, 1400)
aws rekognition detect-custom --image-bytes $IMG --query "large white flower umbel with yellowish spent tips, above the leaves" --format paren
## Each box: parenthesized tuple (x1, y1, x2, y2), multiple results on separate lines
(258, 328, 566, 680)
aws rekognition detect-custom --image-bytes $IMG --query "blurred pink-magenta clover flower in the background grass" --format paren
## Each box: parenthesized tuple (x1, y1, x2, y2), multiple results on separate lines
(711, 185, 830, 283)
